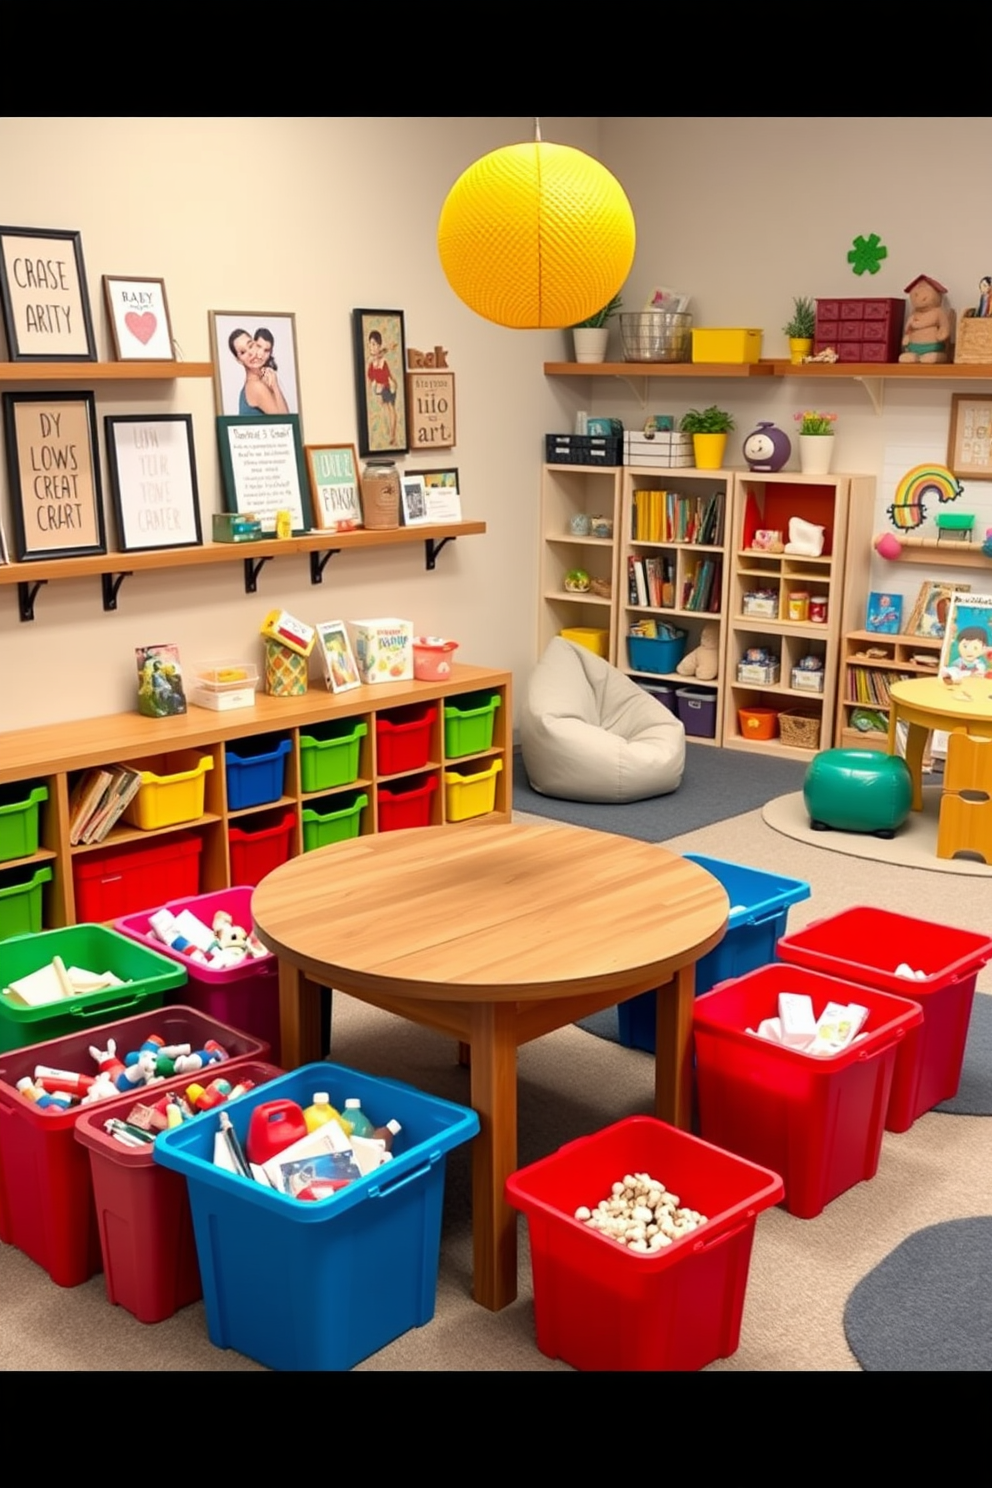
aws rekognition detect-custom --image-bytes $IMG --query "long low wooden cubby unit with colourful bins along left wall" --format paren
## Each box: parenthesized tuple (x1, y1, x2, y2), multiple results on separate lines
(0, 662, 513, 930)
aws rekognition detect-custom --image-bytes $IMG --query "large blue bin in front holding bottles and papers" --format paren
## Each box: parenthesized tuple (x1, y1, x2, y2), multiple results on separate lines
(155, 1062, 479, 1370)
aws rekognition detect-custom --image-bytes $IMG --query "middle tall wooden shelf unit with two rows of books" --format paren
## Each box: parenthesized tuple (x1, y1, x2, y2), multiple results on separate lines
(616, 466, 733, 744)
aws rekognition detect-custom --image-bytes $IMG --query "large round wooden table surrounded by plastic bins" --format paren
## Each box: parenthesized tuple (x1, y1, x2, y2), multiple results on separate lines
(251, 817, 730, 1311)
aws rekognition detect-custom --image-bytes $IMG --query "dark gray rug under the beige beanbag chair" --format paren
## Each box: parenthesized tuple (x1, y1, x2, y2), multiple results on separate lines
(513, 744, 808, 842)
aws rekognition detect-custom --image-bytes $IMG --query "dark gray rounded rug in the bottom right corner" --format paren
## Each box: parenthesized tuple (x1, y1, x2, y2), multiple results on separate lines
(843, 1217, 992, 1373)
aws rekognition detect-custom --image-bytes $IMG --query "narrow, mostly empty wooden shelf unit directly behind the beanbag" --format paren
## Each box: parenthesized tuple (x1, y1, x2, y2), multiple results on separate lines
(537, 464, 623, 661)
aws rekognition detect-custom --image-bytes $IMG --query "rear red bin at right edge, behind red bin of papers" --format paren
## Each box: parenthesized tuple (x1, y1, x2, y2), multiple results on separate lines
(776, 906, 992, 1131)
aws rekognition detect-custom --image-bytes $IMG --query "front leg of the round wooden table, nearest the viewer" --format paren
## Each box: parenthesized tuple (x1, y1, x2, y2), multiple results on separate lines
(470, 1003, 516, 1312)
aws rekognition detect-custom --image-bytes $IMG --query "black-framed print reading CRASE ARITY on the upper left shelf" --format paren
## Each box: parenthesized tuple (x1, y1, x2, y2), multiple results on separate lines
(0, 228, 97, 362)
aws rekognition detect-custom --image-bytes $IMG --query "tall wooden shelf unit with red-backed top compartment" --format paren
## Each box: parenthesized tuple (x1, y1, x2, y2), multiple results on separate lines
(723, 472, 875, 760)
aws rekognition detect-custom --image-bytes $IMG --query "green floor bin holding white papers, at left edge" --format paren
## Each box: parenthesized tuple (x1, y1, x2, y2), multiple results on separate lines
(0, 924, 187, 1052)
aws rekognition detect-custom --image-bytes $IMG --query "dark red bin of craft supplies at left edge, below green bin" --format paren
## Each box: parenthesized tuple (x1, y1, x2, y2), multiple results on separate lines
(0, 1007, 269, 1287)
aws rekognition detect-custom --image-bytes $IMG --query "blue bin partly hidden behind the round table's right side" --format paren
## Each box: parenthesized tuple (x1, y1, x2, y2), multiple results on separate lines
(617, 853, 811, 1054)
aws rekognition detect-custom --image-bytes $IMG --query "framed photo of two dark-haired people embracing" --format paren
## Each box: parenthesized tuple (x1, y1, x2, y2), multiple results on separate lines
(208, 310, 300, 418)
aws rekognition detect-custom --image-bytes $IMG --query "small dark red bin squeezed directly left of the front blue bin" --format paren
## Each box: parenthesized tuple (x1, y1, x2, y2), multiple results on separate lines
(74, 1059, 284, 1323)
